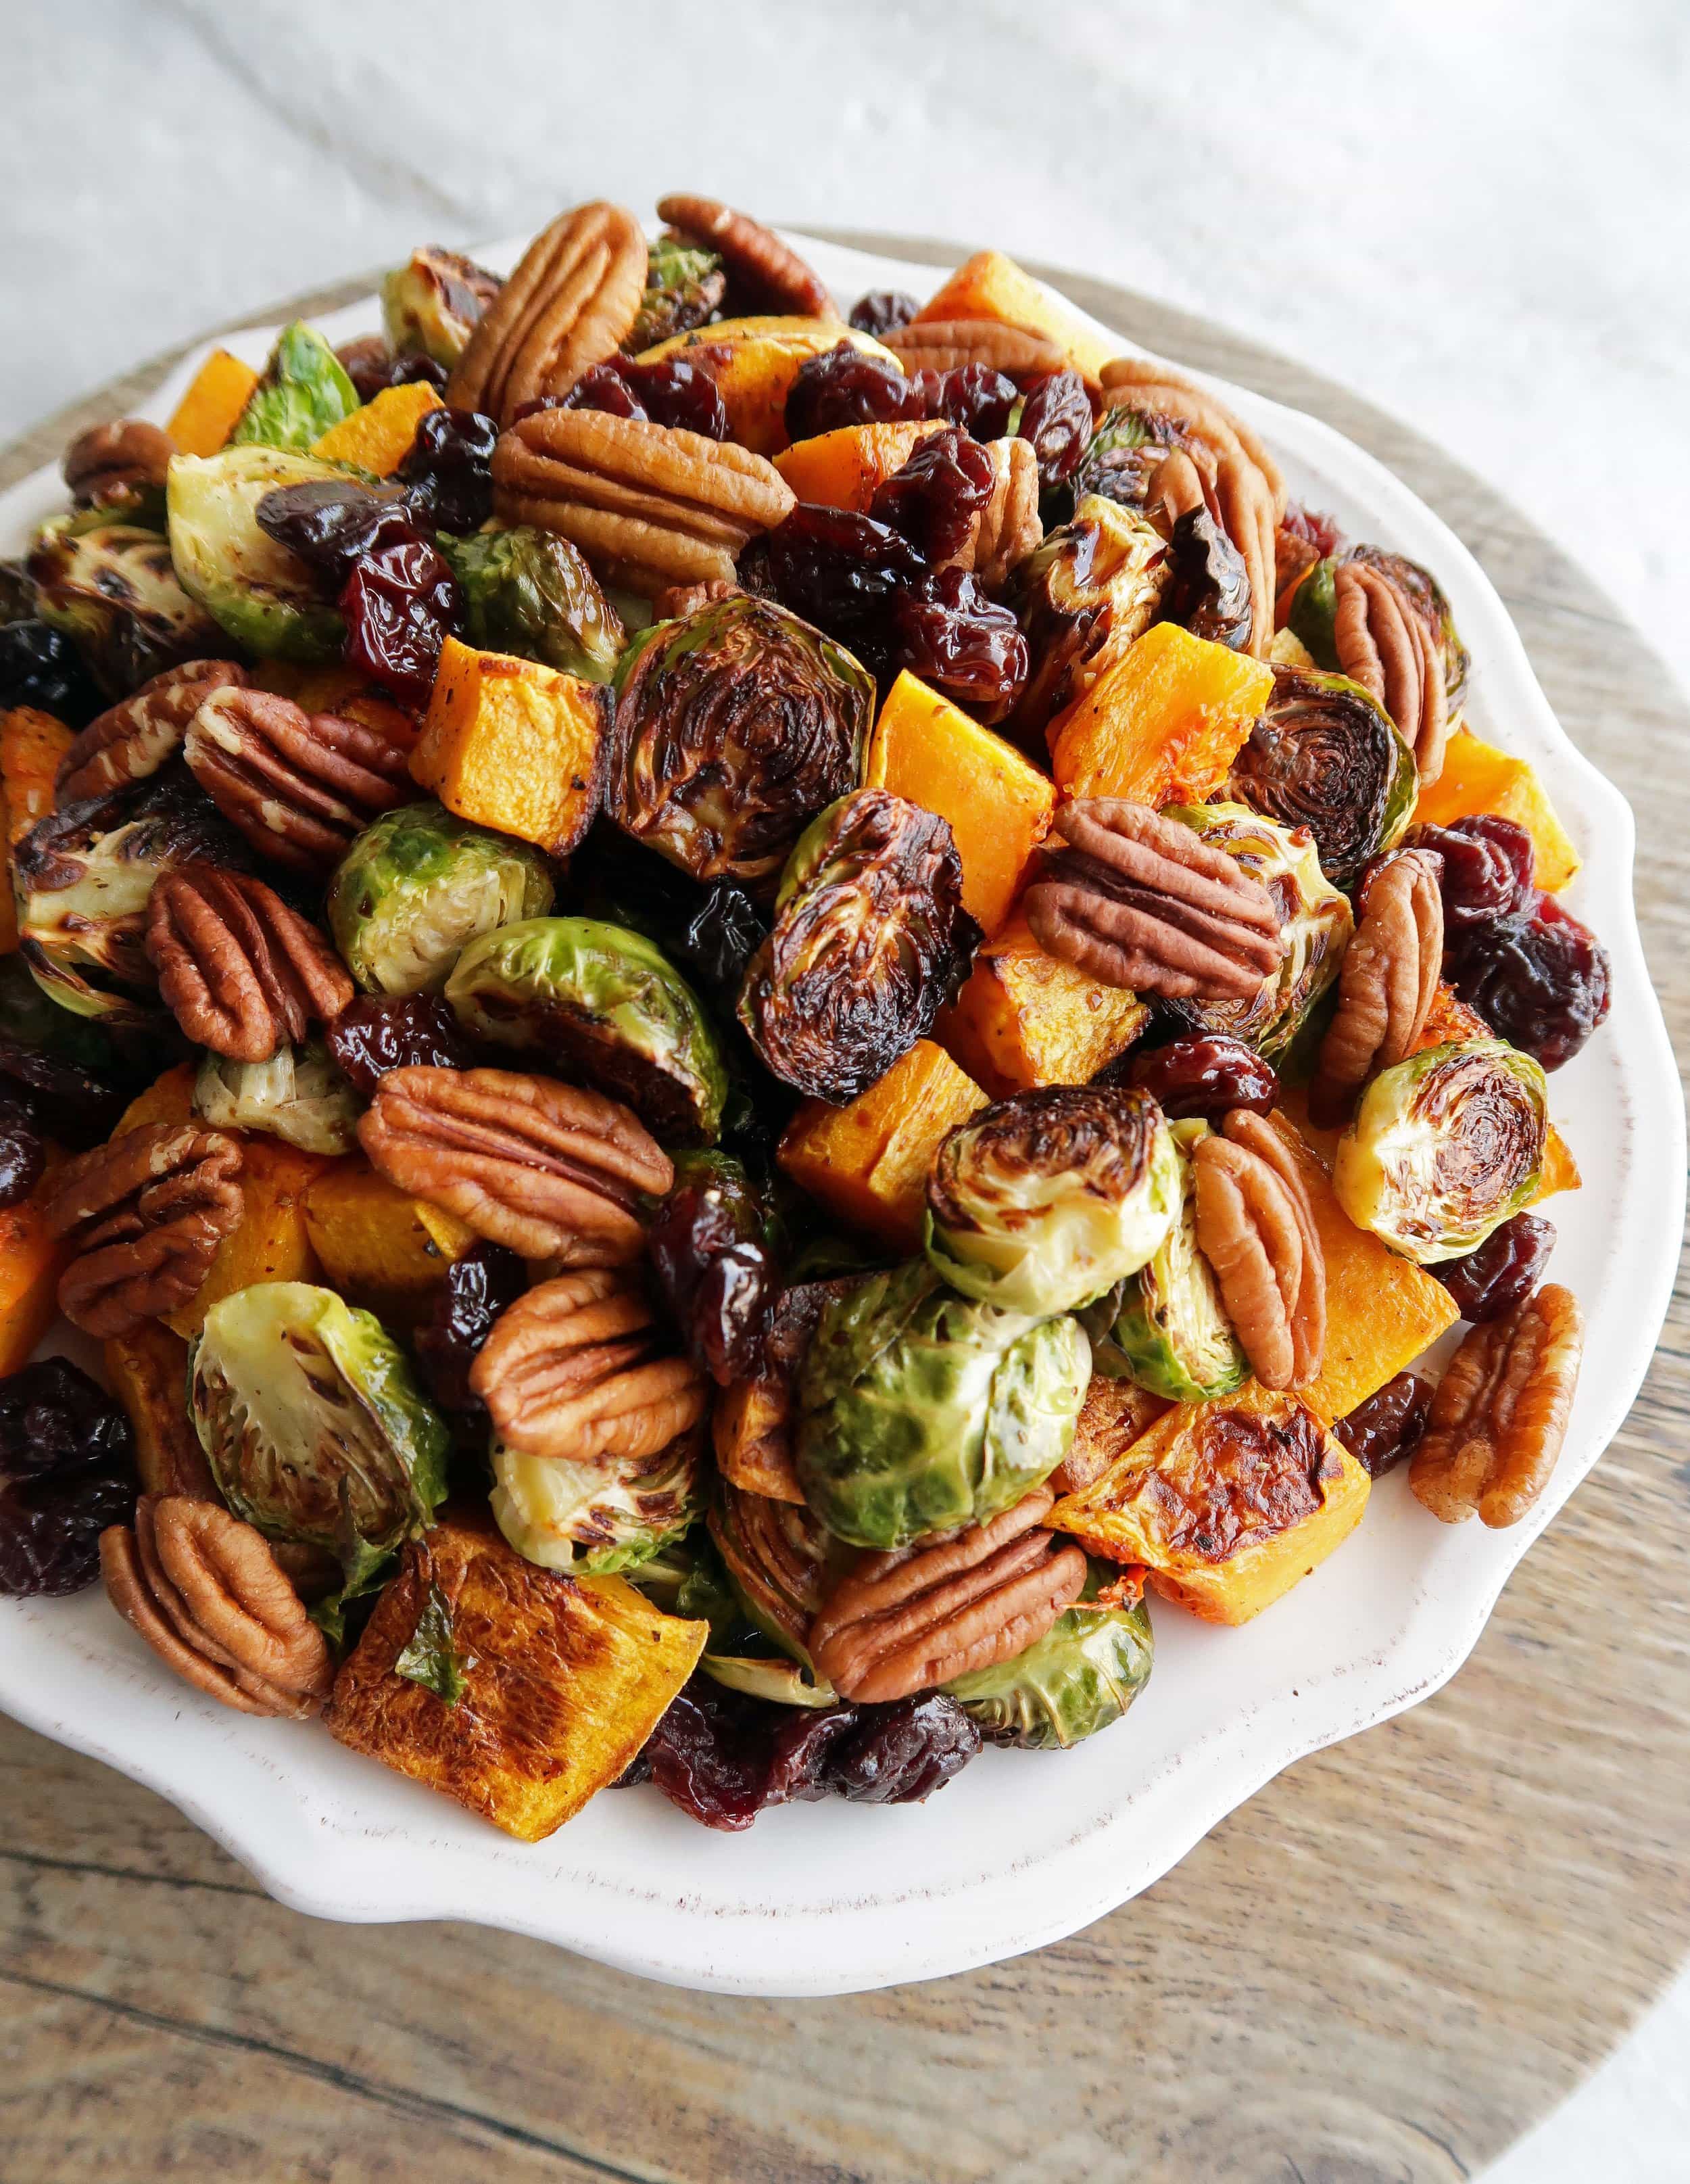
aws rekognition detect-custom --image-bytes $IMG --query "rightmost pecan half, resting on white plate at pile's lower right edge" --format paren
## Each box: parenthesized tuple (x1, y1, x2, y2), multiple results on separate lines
(1408, 1282, 1585, 1529)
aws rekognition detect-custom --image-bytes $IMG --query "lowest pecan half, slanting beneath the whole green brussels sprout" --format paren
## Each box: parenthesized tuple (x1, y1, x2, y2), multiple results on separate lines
(810, 1488, 1085, 1706)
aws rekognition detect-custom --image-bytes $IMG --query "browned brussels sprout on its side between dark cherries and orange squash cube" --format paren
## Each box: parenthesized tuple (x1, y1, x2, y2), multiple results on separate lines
(1009, 494, 1168, 736)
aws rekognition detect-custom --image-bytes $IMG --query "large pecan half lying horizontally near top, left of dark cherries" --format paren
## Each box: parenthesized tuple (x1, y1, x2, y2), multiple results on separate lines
(493, 410, 795, 596)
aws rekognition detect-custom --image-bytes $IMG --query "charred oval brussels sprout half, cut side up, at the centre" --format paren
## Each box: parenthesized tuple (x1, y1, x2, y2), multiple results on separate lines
(738, 788, 980, 1105)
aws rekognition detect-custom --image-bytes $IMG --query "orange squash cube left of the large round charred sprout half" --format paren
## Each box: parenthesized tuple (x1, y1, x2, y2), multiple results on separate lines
(410, 638, 611, 856)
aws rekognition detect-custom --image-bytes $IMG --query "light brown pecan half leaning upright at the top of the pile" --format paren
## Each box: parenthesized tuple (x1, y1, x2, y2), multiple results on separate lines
(445, 201, 646, 424)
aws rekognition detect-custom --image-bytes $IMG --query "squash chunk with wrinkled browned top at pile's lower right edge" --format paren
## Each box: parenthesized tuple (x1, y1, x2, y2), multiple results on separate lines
(1046, 1380, 1371, 1623)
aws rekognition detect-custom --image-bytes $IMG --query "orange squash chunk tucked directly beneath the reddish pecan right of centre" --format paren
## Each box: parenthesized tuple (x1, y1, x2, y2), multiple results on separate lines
(932, 911, 1151, 1099)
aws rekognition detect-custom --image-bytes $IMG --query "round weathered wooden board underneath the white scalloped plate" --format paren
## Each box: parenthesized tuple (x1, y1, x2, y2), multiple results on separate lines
(0, 236, 1690, 2184)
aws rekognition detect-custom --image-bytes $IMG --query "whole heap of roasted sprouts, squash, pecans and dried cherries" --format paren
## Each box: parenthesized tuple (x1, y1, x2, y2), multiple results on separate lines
(0, 197, 1607, 1839)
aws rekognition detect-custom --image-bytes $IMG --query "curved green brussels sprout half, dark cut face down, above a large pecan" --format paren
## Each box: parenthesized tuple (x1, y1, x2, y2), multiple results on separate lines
(445, 918, 727, 1145)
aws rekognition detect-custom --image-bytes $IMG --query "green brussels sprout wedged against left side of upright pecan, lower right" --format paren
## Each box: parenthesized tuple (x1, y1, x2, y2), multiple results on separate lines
(1081, 1120, 1249, 1402)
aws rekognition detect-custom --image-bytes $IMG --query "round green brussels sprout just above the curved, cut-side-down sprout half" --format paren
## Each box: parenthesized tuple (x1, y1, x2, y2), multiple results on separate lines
(327, 804, 552, 994)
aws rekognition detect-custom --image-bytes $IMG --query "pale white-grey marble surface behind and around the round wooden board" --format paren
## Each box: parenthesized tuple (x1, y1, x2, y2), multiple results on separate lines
(0, 0, 1690, 2184)
